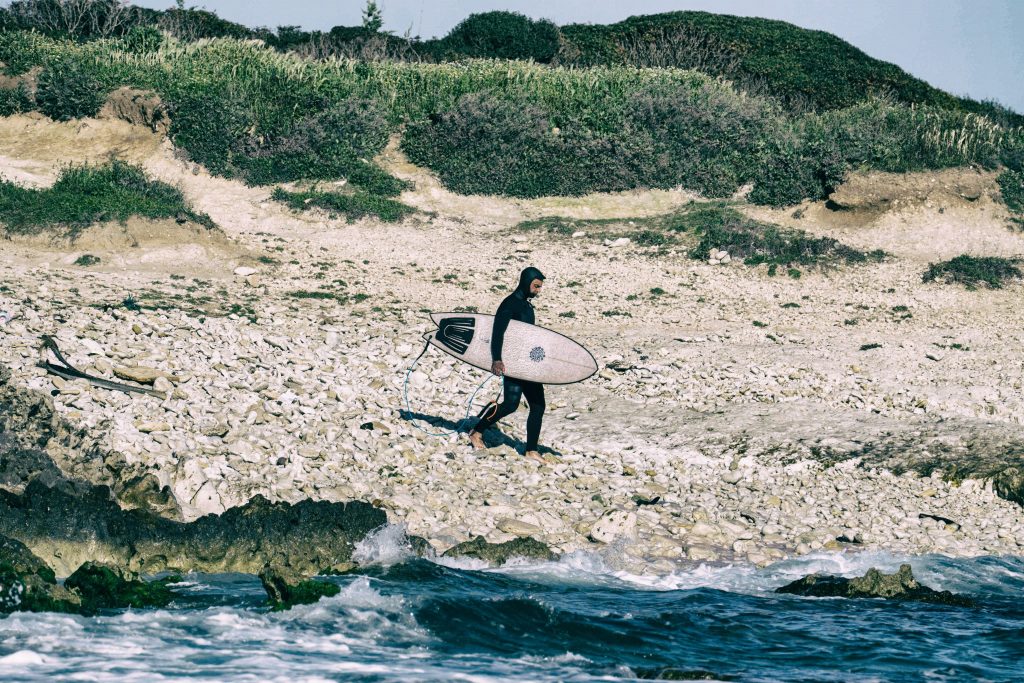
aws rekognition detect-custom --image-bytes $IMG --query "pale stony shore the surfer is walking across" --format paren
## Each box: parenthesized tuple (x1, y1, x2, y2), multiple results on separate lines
(0, 116, 1024, 573)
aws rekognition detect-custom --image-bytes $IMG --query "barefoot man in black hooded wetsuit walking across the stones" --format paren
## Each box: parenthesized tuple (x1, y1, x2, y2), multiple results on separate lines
(469, 266, 544, 462)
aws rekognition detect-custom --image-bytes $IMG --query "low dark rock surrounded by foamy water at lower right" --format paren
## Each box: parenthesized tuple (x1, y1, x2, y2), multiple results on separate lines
(775, 564, 975, 607)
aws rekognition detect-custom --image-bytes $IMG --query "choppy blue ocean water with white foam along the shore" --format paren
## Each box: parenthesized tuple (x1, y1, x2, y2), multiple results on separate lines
(0, 529, 1024, 683)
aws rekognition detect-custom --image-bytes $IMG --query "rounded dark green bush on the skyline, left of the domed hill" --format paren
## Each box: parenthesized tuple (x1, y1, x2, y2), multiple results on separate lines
(436, 11, 559, 63)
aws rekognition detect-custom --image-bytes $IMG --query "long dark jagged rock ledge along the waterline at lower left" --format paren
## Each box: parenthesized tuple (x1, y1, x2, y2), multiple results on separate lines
(0, 481, 387, 575)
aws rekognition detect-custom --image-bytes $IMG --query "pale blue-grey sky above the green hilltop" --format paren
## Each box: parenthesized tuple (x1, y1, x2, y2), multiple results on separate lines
(132, 0, 1024, 114)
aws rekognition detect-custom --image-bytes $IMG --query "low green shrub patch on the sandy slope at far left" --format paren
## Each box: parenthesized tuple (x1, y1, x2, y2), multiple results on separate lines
(0, 161, 213, 237)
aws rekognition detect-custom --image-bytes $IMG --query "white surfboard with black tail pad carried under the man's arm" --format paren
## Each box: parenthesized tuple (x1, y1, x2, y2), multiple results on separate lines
(428, 312, 597, 384)
